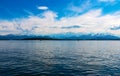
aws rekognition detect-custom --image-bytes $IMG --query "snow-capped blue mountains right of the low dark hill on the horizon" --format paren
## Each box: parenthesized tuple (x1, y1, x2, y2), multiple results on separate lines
(48, 33, 120, 40)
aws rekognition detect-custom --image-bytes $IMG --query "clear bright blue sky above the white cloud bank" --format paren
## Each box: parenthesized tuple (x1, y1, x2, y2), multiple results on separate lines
(0, 0, 120, 19)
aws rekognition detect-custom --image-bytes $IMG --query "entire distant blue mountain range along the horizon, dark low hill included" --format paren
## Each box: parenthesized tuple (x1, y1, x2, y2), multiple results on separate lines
(0, 32, 120, 40)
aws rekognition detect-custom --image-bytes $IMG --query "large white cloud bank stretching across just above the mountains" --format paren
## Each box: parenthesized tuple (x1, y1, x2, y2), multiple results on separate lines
(0, 9, 120, 36)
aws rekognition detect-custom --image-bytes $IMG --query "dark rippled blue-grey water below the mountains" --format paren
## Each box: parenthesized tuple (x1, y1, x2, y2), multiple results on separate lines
(0, 40, 120, 76)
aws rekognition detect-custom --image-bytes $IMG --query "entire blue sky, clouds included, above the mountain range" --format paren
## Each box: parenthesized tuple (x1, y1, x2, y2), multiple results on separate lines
(0, 0, 120, 36)
